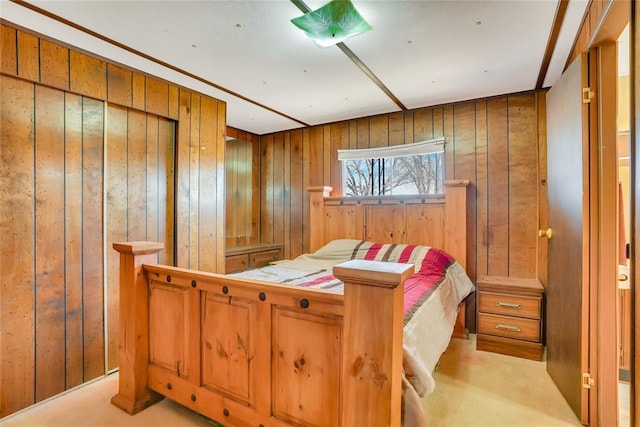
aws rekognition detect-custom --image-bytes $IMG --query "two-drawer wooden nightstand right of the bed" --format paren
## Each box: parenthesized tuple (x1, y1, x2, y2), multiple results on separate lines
(476, 276, 544, 360)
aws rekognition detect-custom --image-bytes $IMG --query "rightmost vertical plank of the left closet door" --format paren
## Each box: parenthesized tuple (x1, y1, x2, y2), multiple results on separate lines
(82, 98, 105, 381)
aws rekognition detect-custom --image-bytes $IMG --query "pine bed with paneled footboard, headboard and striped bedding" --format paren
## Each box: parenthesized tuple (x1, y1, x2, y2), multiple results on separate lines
(112, 182, 473, 426)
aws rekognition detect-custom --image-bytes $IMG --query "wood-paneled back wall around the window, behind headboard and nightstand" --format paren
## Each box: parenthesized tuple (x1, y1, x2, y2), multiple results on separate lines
(260, 92, 546, 331)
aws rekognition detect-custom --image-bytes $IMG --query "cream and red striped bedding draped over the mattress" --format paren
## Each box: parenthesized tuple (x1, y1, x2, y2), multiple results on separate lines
(233, 239, 475, 396)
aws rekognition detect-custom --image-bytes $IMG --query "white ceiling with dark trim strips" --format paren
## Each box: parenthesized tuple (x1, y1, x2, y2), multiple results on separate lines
(0, 0, 588, 134)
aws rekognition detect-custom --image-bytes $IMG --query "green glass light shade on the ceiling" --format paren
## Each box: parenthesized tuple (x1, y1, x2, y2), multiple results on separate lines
(291, 0, 371, 47)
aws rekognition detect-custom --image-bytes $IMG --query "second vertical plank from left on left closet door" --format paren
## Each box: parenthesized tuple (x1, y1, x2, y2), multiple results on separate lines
(34, 85, 65, 402)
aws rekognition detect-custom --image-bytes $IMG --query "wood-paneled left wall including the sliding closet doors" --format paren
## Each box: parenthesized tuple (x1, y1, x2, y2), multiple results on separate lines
(0, 21, 226, 417)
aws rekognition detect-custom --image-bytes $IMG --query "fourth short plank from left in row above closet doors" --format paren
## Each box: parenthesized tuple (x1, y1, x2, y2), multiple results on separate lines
(69, 50, 107, 99)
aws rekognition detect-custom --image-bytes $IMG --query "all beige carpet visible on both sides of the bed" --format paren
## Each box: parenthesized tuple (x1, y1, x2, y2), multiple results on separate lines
(0, 335, 608, 427)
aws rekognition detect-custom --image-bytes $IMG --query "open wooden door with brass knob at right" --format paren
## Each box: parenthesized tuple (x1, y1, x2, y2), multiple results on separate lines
(545, 54, 590, 424)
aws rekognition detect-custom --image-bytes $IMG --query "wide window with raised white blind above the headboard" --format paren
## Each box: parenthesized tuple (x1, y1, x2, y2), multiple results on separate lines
(338, 138, 444, 196)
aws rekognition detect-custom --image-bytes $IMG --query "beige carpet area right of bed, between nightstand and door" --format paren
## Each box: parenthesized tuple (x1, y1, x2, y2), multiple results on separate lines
(424, 335, 581, 427)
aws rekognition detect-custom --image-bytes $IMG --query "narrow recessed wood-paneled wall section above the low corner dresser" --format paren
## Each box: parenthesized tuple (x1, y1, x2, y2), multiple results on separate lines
(225, 126, 260, 248)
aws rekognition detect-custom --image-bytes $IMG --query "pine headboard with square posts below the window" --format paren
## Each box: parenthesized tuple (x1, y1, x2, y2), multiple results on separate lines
(307, 179, 469, 269)
